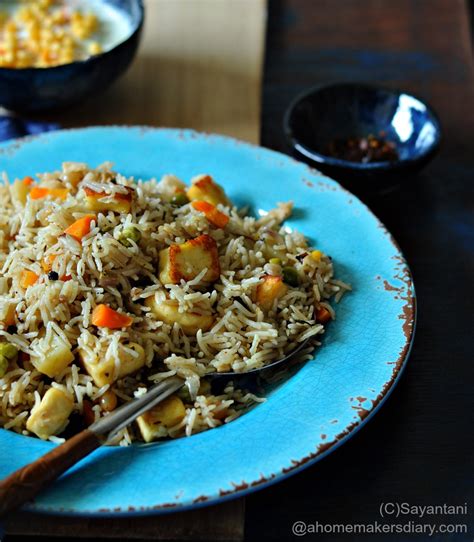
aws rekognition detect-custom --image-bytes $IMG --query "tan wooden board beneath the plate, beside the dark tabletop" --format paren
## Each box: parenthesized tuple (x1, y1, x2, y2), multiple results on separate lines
(5, 0, 266, 541)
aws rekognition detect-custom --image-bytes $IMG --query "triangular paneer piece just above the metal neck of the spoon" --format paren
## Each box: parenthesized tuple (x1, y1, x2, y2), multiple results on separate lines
(78, 343, 146, 388)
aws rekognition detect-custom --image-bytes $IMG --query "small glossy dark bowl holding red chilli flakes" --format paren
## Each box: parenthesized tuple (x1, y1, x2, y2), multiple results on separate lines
(284, 83, 441, 188)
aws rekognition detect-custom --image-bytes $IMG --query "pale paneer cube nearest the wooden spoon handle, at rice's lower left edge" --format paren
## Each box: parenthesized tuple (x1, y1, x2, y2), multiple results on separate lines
(26, 388, 74, 440)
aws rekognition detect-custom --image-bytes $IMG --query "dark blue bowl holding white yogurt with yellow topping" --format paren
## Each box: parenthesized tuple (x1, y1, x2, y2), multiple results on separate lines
(0, 0, 144, 112)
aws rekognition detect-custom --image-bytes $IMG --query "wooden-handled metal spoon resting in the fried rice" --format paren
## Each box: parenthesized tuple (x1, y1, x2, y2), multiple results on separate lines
(0, 339, 309, 517)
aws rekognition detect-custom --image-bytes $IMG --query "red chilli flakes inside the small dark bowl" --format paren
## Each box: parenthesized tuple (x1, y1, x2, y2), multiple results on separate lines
(326, 131, 399, 164)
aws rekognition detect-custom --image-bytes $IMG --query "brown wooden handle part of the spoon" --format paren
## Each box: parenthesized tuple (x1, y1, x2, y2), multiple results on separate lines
(0, 429, 101, 517)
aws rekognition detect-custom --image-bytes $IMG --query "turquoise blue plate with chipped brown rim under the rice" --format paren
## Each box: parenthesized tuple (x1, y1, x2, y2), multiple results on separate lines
(0, 127, 415, 515)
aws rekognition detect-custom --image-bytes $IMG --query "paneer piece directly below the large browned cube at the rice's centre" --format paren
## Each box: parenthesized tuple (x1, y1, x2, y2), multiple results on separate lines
(145, 295, 214, 335)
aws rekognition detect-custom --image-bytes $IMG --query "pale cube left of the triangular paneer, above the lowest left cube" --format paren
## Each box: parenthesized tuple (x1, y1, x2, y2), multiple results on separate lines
(30, 333, 74, 378)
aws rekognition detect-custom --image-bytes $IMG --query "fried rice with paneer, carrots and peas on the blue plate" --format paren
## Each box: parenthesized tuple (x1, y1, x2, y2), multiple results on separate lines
(0, 162, 350, 445)
